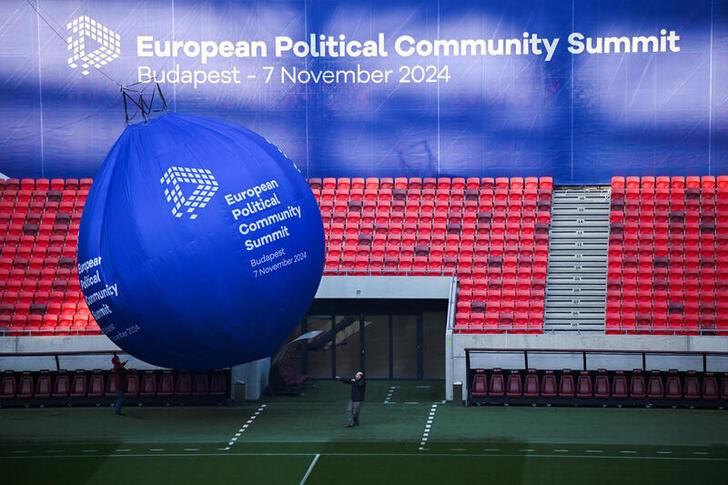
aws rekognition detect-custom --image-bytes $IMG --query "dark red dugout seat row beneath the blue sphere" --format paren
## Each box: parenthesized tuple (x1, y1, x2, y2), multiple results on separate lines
(0, 369, 229, 398)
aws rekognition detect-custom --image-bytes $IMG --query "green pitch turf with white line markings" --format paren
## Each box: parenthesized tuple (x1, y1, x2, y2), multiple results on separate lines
(0, 382, 728, 485)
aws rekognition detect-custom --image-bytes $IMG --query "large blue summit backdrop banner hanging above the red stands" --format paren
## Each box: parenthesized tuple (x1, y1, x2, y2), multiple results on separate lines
(0, 0, 728, 183)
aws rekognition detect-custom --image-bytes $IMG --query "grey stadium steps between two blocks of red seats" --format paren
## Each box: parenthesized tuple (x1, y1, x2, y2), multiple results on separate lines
(544, 187, 610, 332)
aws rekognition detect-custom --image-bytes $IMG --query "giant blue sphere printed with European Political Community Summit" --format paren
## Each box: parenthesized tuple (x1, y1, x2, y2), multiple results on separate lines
(78, 114, 324, 369)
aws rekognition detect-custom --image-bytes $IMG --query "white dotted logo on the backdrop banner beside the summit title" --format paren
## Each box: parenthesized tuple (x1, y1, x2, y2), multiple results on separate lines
(66, 15, 121, 76)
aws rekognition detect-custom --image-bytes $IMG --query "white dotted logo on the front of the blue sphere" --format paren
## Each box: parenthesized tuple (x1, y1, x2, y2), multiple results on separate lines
(159, 167, 219, 219)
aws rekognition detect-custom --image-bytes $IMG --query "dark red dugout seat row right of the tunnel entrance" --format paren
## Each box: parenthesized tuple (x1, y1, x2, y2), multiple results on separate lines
(469, 369, 728, 404)
